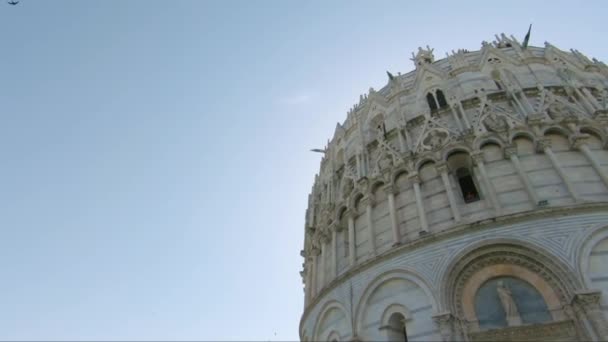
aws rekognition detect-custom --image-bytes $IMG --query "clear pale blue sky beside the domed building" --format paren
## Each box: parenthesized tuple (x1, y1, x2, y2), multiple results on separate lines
(0, 0, 608, 340)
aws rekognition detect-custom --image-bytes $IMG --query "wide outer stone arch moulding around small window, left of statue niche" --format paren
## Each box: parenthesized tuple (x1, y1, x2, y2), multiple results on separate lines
(354, 269, 437, 332)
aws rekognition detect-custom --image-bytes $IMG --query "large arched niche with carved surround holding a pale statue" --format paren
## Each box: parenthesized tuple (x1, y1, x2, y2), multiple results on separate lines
(442, 239, 585, 340)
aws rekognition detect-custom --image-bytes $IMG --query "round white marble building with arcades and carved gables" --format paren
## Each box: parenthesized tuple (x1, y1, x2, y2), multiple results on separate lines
(299, 34, 608, 342)
